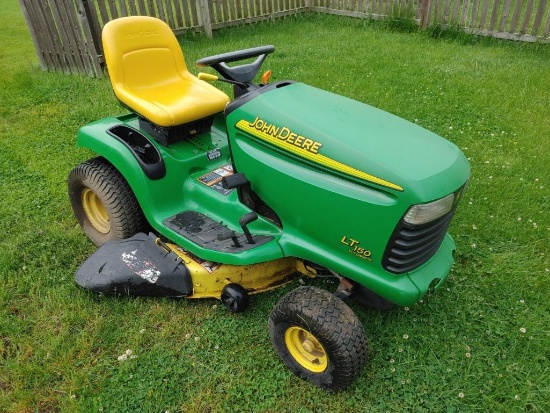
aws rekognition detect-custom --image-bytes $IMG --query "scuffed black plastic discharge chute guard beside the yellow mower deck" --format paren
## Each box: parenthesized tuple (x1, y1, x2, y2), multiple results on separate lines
(75, 233, 193, 297)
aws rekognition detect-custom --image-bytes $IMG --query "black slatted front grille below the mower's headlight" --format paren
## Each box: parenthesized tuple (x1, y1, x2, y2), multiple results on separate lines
(382, 205, 456, 274)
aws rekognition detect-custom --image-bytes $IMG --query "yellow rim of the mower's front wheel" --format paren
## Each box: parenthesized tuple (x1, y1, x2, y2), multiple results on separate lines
(285, 326, 328, 373)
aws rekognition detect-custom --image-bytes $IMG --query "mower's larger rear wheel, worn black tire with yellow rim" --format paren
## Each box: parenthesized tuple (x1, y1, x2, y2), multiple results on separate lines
(68, 158, 147, 246)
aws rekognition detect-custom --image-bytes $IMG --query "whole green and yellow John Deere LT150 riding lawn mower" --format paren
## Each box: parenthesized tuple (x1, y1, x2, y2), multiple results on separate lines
(68, 17, 470, 390)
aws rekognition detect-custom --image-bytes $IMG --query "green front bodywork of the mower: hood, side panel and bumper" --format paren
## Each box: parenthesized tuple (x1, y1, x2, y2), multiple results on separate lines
(226, 83, 470, 305)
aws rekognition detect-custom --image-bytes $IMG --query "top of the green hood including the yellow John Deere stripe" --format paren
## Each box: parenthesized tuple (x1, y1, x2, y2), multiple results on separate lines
(228, 83, 469, 201)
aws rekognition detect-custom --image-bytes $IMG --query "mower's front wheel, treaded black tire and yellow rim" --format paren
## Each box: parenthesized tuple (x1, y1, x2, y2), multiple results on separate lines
(268, 286, 367, 391)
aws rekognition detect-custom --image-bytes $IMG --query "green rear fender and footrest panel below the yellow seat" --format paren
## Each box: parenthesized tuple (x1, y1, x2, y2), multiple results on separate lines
(77, 115, 283, 265)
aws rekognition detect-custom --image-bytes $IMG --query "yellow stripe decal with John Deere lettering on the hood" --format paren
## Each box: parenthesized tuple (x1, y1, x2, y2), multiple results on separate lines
(235, 118, 403, 191)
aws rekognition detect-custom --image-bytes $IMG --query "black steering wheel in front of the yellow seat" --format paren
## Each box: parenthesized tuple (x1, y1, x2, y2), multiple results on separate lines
(196, 45, 275, 83)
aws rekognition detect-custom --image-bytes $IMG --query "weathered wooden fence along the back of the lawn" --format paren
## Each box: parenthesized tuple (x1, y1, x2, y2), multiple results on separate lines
(19, 0, 550, 76)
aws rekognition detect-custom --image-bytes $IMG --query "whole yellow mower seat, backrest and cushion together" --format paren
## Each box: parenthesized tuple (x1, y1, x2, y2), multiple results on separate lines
(102, 16, 229, 128)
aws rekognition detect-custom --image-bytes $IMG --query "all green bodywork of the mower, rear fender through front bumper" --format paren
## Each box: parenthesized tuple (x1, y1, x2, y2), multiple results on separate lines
(78, 83, 469, 305)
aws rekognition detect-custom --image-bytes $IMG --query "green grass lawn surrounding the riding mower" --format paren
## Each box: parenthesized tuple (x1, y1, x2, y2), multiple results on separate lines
(0, 0, 550, 412)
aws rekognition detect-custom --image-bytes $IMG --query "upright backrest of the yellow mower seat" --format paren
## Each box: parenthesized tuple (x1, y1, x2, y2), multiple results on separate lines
(102, 16, 188, 96)
